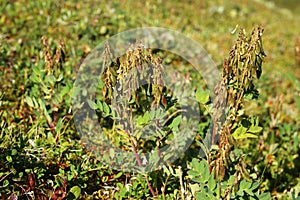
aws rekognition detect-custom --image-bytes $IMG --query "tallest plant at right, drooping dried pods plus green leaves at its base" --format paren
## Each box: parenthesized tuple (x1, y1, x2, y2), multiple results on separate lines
(188, 27, 270, 199)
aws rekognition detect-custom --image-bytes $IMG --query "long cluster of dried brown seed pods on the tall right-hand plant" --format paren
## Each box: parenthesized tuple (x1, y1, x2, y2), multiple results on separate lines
(213, 26, 266, 180)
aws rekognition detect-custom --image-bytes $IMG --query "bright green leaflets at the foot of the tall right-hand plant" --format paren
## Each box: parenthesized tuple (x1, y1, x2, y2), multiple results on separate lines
(187, 158, 271, 199)
